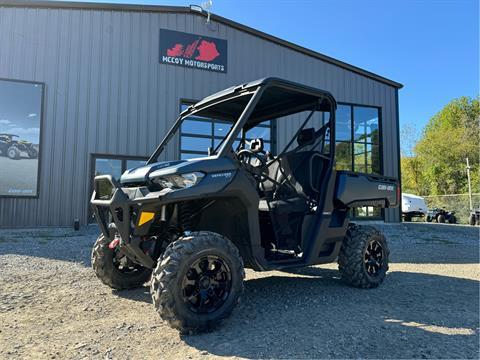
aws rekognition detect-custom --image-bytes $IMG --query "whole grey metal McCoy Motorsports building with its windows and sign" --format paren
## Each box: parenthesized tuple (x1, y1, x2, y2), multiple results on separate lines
(0, 0, 402, 227)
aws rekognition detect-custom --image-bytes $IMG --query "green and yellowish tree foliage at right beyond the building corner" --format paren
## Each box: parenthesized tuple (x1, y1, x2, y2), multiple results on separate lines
(402, 97, 480, 195)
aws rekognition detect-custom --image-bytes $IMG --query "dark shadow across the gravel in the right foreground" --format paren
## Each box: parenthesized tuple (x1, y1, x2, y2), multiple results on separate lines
(182, 268, 479, 358)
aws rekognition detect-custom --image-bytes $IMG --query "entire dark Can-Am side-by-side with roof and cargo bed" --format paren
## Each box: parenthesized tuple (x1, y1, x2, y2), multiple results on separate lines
(91, 78, 399, 331)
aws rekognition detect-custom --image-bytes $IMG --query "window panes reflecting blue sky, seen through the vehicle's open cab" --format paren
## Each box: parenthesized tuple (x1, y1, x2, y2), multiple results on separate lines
(180, 101, 275, 160)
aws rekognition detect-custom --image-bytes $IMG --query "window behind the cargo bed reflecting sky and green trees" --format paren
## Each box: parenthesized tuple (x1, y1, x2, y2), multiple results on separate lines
(335, 104, 383, 218)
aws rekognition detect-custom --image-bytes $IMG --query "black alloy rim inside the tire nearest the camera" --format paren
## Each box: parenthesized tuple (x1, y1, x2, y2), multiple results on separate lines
(182, 255, 232, 314)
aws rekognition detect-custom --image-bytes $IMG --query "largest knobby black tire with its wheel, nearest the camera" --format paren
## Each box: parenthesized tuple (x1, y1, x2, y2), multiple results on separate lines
(150, 231, 245, 333)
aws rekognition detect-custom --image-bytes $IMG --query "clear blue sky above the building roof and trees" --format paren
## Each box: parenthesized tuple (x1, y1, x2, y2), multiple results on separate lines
(54, 0, 480, 152)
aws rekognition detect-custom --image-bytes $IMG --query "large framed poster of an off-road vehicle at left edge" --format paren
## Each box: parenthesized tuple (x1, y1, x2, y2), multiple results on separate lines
(0, 79, 44, 197)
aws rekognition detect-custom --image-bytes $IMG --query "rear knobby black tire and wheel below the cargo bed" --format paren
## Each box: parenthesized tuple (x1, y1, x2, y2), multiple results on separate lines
(338, 224, 390, 289)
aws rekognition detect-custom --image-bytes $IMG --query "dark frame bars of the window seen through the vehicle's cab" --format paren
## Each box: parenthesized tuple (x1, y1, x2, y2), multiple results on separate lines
(178, 98, 277, 159)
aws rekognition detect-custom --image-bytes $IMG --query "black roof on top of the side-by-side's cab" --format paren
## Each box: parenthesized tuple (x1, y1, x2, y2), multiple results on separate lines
(182, 78, 336, 128)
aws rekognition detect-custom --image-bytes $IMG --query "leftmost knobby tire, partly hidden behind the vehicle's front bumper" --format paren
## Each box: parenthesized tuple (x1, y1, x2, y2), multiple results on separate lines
(92, 235, 152, 290)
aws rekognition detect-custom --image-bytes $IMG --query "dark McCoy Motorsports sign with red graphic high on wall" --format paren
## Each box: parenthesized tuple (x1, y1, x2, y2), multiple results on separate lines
(160, 29, 227, 73)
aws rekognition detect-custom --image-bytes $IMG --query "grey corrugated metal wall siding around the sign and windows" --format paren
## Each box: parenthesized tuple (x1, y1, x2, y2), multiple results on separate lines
(0, 7, 399, 226)
